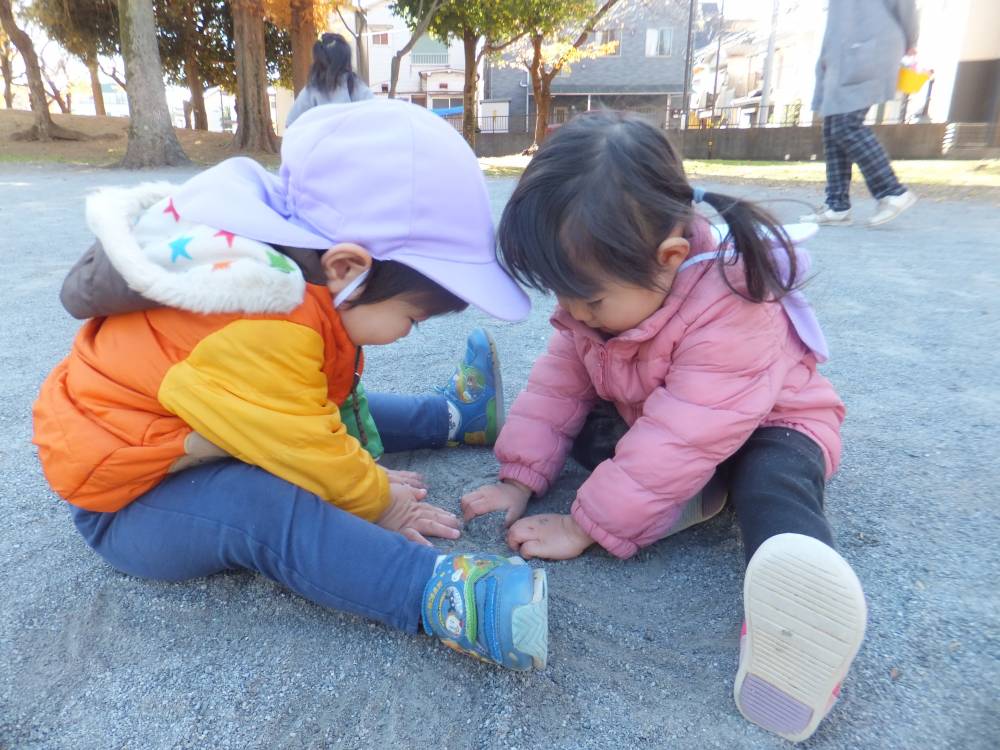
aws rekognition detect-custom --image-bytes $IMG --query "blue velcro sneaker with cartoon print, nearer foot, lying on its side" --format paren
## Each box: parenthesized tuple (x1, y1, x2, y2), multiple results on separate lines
(423, 555, 549, 671)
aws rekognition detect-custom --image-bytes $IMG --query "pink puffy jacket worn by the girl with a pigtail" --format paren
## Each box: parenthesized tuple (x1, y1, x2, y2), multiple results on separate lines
(496, 232, 844, 558)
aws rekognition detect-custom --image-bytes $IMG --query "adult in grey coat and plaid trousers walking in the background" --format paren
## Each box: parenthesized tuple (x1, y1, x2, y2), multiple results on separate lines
(802, 0, 918, 226)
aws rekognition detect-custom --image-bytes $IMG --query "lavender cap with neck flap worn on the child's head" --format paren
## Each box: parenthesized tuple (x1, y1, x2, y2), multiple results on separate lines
(173, 100, 531, 320)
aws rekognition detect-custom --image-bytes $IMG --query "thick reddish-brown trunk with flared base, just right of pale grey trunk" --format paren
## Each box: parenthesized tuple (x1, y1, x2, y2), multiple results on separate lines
(232, 0, 278, 154)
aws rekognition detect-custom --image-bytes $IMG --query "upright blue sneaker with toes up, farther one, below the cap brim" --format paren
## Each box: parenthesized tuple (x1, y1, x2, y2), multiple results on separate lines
(435, 328, 504, 445)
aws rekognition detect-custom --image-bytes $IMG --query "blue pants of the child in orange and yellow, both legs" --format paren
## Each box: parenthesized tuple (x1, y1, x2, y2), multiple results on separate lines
(72, 395, 448, 633)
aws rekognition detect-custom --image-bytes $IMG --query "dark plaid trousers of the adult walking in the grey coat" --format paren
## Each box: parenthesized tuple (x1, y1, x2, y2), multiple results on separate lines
(823, 109, 906, 211)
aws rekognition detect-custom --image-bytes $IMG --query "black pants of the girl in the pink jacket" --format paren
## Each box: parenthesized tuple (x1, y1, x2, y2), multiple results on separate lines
(571, 402, 834, 562)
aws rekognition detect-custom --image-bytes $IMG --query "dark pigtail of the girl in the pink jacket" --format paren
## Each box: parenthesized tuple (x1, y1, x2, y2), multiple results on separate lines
(700, 192, 798, 302)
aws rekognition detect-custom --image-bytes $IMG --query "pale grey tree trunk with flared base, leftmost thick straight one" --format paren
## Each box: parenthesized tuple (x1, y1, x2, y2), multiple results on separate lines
(118, 0, 190, 169)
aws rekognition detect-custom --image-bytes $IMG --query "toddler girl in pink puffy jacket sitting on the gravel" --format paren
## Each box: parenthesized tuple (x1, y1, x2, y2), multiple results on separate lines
(462, 112, 867, 741)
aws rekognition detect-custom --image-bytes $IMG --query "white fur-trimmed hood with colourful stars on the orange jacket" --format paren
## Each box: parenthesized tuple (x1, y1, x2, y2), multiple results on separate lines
(76, 182, 304, 314)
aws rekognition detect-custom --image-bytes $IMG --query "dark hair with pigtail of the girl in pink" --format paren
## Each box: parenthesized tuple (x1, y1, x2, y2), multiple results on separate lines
(497, 111, 797, 302)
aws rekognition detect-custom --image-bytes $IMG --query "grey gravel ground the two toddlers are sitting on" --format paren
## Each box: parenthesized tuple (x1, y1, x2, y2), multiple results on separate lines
(0, 165, 1000, 750)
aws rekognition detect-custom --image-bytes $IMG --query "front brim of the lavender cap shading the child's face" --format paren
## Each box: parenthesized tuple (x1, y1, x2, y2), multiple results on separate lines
(390, 250, 531, 322)
